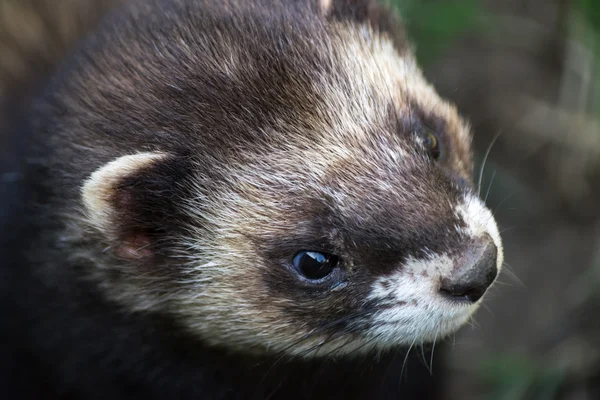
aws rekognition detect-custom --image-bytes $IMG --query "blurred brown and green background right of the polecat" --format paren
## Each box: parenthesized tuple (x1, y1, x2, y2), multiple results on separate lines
(394, 0, 600, 400)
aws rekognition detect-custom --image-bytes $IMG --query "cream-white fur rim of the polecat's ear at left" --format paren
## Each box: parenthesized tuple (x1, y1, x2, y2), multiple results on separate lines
(81, 152, 167, 232)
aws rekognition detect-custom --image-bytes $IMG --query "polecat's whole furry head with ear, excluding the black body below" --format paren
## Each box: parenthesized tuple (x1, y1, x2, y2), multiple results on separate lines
(38, 0, 502, 356)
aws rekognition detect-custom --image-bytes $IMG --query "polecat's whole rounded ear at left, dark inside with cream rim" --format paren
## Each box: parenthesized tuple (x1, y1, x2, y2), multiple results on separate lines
(81, 152, 188, 259)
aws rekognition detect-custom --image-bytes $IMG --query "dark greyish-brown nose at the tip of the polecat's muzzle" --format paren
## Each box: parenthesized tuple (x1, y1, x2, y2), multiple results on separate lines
(440, 239, 498, 303)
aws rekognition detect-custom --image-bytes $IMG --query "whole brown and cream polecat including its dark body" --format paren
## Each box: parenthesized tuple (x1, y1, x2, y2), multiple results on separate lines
(2, 0, 502, 399)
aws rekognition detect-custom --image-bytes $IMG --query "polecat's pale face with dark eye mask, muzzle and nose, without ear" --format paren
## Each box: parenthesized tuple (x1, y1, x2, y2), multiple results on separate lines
(170, 31, 502, 356)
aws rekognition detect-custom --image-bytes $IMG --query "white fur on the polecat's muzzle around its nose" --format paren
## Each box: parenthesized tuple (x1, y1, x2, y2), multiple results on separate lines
(369, 198, 504, 346)
